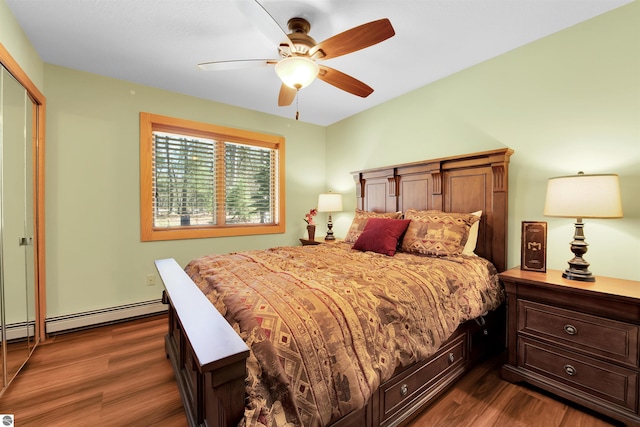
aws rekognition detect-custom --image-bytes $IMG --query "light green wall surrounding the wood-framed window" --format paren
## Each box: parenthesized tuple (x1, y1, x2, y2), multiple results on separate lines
(45, 64, 325, 316)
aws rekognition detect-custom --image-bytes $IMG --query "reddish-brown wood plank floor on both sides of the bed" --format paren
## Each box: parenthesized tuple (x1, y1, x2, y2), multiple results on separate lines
(0, 315, 615, 427)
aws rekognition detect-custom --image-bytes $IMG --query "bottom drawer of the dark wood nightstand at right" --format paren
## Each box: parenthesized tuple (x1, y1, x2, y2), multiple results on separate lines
(518, 338, 638, 412)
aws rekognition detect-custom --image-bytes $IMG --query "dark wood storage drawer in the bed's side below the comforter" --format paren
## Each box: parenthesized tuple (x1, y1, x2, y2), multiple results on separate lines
(380, 334, 467, 421)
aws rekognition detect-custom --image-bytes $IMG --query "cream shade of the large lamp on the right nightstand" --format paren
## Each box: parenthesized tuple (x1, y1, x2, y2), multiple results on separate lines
(544, 172, 622, 218)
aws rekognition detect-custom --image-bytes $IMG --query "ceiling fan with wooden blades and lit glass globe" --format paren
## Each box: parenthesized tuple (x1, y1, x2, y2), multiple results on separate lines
(198, 0, 395, 106)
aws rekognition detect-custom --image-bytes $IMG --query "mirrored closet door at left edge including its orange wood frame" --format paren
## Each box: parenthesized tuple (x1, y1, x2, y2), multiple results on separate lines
(0, 46, 44, 396)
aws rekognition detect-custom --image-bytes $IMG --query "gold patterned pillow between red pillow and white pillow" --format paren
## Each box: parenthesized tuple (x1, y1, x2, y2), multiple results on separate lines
(402, 209, 480, 256)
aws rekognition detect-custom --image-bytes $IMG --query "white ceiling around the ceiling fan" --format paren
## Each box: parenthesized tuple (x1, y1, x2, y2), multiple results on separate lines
(5, 0, 631, 126)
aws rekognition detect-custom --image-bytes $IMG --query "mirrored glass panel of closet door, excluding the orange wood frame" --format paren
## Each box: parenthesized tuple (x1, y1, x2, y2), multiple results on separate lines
(0, 68, 35, 385)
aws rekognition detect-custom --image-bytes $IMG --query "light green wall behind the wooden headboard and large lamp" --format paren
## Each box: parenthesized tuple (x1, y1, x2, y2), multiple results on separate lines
(327, 1, 640, 280)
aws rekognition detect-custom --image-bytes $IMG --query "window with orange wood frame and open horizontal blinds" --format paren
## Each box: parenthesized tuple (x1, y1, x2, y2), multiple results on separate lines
(140, 113, 284, 241)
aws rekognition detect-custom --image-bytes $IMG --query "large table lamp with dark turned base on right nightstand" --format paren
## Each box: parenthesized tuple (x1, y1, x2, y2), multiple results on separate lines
(544, 172, 622, 282)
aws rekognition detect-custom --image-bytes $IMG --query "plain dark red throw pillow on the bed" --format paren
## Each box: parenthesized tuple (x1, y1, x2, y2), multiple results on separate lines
(353, 218, 411, 256)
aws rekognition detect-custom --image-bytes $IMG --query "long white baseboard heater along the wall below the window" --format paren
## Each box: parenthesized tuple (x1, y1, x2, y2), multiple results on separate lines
(45, 299, 167, 334)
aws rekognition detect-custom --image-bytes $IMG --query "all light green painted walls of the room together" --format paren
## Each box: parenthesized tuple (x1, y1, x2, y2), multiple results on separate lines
(0, 0, 640, 317)
